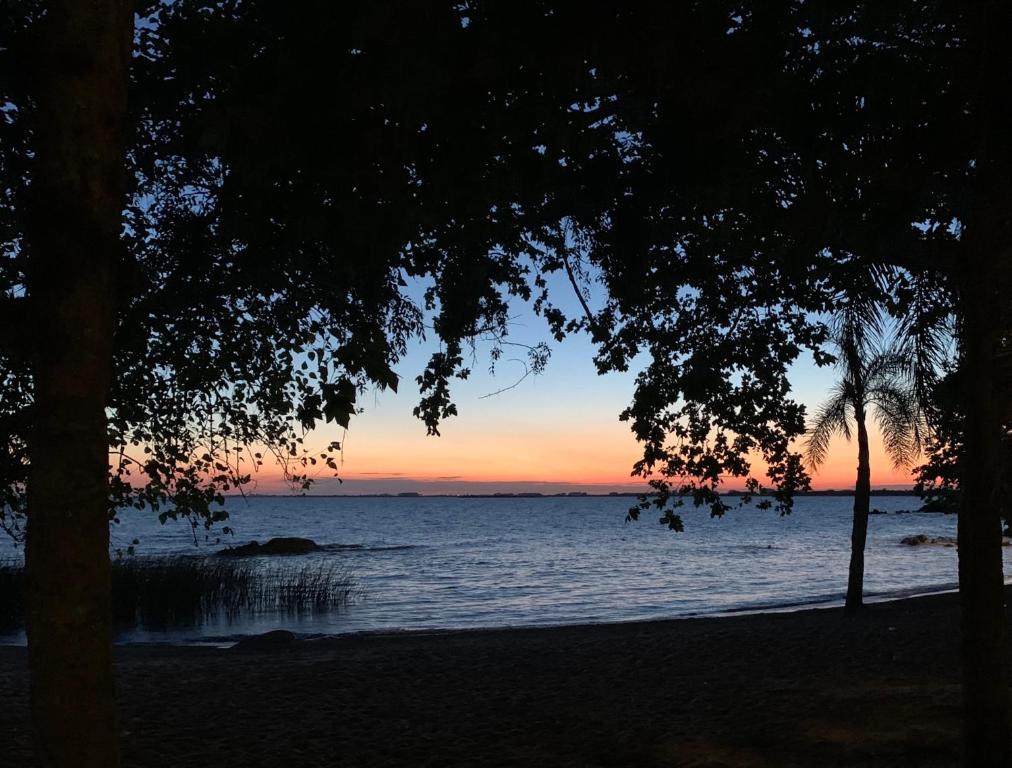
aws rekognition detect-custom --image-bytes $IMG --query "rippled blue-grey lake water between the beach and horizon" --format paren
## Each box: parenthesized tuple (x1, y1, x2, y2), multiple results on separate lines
(0, 497, 956, 642)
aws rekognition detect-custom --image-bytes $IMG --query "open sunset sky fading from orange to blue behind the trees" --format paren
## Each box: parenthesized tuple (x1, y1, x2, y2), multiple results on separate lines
(246, 273, 913, 494)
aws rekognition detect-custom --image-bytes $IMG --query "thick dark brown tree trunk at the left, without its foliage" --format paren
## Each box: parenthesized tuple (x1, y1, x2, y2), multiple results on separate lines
(25, 0, 133, 768)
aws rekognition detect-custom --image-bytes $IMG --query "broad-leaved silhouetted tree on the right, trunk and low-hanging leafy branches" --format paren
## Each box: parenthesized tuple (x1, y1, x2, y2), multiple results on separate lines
(522, 0, 1012, 765)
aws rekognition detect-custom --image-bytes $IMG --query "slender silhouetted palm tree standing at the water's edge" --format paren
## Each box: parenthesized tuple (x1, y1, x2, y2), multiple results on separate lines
(806, 306, 922, 610)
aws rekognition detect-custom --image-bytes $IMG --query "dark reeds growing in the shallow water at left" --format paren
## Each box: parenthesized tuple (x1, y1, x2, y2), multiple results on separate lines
(0, 556, 355, 628)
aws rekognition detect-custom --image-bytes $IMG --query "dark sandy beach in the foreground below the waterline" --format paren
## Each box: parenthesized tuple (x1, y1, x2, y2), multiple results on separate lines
(0, 595, 1003, 768)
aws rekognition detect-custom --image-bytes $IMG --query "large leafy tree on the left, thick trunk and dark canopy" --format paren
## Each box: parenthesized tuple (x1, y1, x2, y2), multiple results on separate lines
(0, 3, 620, 766)
